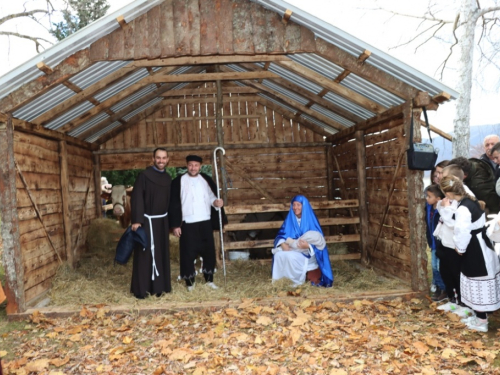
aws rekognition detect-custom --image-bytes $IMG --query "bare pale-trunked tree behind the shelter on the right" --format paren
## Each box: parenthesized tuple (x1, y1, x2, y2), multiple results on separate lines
(378, 0, 500, 157)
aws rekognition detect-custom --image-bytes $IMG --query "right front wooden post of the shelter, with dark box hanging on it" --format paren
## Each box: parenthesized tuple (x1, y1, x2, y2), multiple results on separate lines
(403, 103, 429, 292)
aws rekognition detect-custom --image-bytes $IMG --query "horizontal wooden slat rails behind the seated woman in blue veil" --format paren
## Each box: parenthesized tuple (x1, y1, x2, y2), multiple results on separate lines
(224, 199, 361, 260)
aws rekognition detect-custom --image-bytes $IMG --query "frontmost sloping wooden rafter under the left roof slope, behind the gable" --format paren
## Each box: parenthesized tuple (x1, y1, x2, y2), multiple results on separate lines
(32, 64, 135, 125)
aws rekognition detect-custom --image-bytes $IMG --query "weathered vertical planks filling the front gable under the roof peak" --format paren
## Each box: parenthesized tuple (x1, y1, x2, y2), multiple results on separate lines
(90, 0, 316, 61)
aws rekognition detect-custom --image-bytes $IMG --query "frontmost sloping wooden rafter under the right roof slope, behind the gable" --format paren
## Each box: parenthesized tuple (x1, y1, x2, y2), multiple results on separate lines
(276, 61, 386, 113)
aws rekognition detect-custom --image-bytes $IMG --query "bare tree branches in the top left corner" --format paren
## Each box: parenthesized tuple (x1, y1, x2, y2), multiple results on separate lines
(0, 0, 54, 52)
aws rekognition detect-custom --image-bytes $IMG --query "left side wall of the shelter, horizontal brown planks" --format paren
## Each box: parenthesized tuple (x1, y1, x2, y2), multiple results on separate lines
(14, 132, 95, 304)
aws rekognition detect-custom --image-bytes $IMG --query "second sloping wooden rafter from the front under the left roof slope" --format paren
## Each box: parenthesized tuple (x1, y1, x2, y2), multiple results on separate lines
(57, 67, 183, 133)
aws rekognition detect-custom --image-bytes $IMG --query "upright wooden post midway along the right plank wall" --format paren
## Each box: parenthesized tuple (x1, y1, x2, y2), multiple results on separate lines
(355, 130, 370, 265)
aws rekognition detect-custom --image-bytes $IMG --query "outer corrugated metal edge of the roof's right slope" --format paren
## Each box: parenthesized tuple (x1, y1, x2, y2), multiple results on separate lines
(250, 0, 460, 99)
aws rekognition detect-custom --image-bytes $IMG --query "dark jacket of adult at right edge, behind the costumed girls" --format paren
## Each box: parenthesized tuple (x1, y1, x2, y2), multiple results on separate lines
(464, 158, 500, 214)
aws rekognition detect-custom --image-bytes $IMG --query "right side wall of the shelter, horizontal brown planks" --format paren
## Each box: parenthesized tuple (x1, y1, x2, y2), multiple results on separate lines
(332, 115, 411, 281)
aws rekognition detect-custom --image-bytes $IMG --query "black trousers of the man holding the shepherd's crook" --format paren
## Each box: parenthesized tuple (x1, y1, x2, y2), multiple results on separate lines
(179, 220, 215, 286)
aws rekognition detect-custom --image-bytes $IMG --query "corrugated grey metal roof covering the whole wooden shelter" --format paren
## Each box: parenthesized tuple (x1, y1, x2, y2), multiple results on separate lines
(0, 0, 458, 142)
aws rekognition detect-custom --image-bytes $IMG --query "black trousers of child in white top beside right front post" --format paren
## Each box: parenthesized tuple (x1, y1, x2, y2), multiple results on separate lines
(436, 241, 462, 303)
